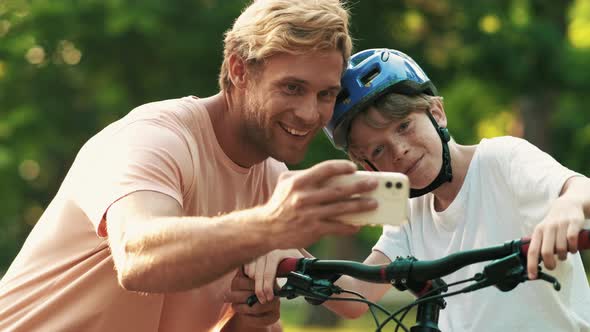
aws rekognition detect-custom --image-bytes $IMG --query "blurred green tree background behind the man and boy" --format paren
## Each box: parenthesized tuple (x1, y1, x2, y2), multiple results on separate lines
(0, 0, 590, 330)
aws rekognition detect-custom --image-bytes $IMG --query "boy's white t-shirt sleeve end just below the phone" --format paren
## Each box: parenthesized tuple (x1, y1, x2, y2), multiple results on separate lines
(373, 224, 413, 261)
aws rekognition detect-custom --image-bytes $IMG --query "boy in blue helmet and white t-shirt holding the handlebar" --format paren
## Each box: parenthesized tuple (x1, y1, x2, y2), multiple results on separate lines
(246, 49, 590, 331)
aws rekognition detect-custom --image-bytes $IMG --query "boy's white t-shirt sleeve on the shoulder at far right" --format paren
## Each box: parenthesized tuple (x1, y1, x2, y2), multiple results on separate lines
(503, 139, 580, 230)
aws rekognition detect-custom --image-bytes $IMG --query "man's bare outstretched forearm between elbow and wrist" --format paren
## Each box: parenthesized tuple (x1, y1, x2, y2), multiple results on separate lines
(118, 209, 272, 292)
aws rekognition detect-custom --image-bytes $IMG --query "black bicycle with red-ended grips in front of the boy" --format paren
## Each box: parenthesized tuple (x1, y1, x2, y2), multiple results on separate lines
(247, 229, 590, 332)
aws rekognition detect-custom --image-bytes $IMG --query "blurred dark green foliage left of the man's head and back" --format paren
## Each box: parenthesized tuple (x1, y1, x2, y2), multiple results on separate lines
(0, 0, 243, 274)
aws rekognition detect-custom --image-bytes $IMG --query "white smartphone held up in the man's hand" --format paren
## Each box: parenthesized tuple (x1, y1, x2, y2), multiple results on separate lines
(326, 171, 410, 225)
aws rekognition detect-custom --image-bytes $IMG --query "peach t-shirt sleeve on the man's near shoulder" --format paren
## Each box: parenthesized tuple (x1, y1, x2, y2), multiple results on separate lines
(74, 121, 193, 237)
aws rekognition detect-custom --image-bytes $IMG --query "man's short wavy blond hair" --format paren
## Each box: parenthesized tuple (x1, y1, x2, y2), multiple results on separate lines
(219, 0, 352, 90)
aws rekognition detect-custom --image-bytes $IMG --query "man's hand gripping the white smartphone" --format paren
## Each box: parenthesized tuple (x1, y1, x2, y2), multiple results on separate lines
(262, 160, 378, 249)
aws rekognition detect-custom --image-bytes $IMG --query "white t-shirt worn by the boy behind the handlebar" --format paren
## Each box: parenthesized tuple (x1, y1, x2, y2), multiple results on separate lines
(373, 137, 590, 332)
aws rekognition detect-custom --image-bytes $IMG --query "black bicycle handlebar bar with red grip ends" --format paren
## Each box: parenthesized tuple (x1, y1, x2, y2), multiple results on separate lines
(277, 229, 590, 283)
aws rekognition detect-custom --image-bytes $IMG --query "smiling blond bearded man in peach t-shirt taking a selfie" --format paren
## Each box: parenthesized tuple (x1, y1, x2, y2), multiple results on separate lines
(0, 0, 376, 331)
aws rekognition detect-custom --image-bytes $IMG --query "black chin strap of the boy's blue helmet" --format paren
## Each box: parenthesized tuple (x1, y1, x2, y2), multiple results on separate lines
(364, 112, 453, 198)
